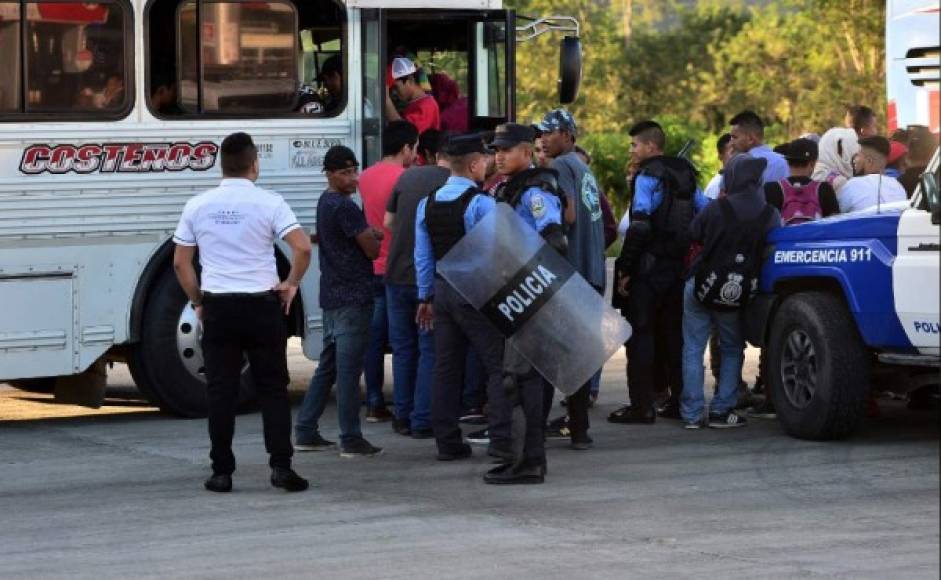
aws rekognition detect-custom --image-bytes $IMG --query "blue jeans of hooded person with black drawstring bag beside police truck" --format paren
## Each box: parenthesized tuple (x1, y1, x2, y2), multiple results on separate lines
(680, 278, 745, 421)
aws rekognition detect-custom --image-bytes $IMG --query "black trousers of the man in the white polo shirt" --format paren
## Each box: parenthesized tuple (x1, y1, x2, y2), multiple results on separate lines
(202, 294, 294, 474)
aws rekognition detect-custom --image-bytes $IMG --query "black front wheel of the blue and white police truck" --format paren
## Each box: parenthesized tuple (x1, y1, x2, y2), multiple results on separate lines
(767, 292, 869, 440)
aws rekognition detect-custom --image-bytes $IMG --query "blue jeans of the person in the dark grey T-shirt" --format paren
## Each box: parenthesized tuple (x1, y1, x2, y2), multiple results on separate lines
(386, 284, 435, 430)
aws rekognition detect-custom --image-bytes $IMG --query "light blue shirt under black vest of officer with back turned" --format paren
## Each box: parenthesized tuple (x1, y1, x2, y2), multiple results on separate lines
(415, 175, 496, 300)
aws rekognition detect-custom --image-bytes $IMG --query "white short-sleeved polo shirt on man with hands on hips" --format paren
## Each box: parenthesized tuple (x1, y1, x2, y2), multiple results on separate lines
(173, 178, 301, 293)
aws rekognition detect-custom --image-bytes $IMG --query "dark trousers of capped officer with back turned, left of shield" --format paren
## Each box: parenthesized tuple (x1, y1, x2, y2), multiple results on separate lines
(431, 279, 511, 453)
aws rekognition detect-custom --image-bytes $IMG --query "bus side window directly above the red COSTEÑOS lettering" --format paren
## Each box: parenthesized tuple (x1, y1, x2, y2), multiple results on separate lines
(146, 0, 346, 119)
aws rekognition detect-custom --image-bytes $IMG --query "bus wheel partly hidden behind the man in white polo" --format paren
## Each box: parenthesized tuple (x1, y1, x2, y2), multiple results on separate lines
(129, 268, 255, 417)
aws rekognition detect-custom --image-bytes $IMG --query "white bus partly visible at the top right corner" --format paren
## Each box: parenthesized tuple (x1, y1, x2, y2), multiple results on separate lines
(885, 0, 941, 134)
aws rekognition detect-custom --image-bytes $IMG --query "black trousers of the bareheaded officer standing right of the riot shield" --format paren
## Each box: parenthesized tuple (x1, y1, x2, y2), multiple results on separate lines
(627, 277, 683, 410)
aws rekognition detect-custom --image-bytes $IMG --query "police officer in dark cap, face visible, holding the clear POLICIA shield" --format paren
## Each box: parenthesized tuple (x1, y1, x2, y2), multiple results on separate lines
(484, 123, 568, 484)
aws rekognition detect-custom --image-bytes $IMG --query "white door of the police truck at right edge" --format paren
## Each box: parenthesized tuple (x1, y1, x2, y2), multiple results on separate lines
(892, 153, 941, 355)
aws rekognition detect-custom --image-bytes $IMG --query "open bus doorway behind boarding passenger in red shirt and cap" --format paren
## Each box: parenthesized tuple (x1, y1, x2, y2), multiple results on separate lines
(361, 9, 516, 167)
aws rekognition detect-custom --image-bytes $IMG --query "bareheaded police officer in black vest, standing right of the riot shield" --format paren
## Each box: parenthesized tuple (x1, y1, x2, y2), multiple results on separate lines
(608, 121, 709, 424)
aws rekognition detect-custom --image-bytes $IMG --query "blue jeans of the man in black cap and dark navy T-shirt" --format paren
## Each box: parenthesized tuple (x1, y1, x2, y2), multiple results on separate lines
(295, 304, 373, 444)
